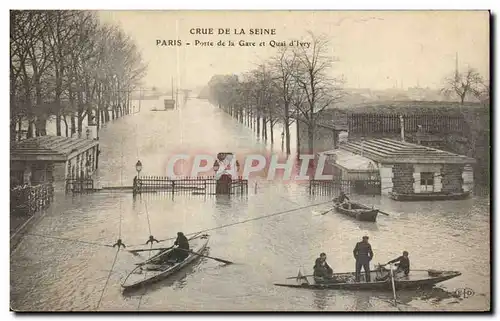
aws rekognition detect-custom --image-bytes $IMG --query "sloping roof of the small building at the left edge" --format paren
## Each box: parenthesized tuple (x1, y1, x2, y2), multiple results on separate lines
(10, 136, 99, 161)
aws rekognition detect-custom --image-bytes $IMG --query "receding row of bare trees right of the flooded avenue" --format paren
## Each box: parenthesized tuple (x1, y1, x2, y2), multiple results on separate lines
(208, 33, 343, 154)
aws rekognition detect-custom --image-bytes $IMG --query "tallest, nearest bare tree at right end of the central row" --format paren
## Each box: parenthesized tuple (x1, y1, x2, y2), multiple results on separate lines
(293, 32, 343, 153)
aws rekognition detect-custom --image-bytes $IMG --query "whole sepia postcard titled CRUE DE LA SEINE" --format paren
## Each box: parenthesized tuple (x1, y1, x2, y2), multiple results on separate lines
(9, 10, 492, 312)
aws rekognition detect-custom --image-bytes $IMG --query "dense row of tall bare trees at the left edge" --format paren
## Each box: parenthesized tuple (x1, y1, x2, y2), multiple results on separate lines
(10, 10, 147, 140)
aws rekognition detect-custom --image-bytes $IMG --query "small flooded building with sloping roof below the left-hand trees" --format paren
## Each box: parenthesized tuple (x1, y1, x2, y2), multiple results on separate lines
(10, 136, 99, 189)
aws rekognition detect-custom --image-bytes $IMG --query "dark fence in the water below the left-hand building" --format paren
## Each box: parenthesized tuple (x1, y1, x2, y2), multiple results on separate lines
(10, 183, 54, 215)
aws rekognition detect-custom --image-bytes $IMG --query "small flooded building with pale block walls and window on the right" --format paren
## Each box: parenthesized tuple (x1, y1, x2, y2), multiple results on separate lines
(341, 139, 475, 199)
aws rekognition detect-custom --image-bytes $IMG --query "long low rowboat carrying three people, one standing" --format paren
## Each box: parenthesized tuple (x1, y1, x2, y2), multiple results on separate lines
(274, 270, 461, 291)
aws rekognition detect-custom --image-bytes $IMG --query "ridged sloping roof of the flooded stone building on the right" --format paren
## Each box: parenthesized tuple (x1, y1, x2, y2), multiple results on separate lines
(340, 139, 476, 164)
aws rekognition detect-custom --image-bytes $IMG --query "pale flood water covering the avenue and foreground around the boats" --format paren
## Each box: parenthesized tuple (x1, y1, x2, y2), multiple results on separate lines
(10, 99, 490, 311)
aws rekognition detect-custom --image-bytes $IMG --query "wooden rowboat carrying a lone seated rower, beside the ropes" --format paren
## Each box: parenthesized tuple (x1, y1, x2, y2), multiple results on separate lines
(122, 235, 209, 289)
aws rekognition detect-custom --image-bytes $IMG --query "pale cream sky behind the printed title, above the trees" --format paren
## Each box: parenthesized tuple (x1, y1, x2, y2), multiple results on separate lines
(99, 10, 490, 89)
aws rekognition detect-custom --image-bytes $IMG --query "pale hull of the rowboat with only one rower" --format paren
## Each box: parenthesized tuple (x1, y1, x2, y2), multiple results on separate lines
(122, 236, 209, 289)
